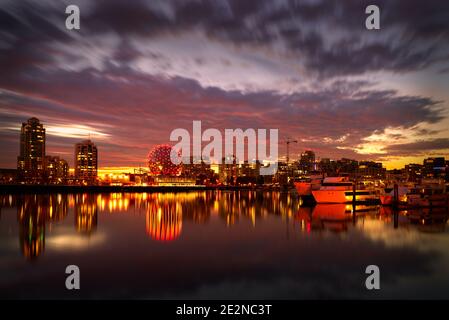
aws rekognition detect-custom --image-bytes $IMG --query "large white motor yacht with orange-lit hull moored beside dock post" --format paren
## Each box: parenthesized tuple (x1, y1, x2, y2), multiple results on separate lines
(312, 176, 380, 203)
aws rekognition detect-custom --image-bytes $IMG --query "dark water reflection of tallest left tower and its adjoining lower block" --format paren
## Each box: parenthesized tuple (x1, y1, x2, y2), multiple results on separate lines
(16, 194, 68, 259)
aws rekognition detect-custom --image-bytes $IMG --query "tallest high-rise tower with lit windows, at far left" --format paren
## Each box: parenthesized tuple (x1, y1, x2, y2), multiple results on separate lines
(17, 118, 45, 180)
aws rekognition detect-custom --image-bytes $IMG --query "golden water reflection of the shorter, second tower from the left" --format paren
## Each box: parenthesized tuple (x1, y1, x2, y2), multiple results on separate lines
(75, 194, 98, 234)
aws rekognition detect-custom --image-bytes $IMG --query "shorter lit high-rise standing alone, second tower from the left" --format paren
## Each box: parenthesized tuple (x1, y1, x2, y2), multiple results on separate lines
(75, 140, 98, 183)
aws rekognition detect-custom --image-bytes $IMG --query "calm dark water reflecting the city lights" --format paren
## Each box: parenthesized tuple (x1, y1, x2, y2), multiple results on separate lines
(0, 191, 449, 299)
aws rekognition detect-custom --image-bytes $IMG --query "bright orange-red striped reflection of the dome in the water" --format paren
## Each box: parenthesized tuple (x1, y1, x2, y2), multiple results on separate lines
(146, 202, 182, 241)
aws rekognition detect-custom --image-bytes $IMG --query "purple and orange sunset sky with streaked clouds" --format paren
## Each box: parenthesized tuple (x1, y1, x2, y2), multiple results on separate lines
(0, 0, 449, 168)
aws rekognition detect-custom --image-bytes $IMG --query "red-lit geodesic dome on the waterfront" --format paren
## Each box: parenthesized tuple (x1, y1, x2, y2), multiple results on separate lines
(148, 144, 181, 176)
